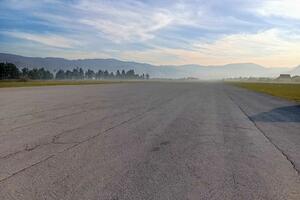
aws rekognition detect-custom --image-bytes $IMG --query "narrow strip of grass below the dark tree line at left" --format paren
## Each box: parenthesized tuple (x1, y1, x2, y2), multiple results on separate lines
(0, 80, 131, 88)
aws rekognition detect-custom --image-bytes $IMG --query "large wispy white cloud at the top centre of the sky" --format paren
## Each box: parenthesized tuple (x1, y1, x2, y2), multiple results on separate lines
(76, 0, 193, 42)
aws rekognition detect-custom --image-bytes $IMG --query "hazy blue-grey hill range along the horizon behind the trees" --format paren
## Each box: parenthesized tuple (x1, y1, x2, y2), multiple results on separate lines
(0, 53, 300, 79)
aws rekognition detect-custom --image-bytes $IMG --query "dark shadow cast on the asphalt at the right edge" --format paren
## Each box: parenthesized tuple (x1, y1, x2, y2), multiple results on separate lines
(250, 105, 300, 122)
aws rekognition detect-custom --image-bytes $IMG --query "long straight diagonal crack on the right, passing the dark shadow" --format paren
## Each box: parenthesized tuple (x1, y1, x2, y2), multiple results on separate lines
(226, 92, 300, 176)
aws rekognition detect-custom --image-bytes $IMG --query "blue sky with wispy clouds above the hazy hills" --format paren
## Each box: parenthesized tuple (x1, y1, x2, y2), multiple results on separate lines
(0, 0, 300, 67)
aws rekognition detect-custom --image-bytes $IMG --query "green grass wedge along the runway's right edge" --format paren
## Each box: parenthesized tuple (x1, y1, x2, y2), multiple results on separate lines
(232, 82, 300, 103)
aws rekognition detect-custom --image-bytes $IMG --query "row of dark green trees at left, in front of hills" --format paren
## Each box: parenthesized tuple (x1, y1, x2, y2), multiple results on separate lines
(0, 63, 150, 80)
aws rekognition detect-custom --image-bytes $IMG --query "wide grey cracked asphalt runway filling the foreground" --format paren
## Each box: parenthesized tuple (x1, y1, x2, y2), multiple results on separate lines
(0, 82, 300, 200)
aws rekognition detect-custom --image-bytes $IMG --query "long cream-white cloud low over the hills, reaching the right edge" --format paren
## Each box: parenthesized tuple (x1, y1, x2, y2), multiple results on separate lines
(122, 29, 300, 67)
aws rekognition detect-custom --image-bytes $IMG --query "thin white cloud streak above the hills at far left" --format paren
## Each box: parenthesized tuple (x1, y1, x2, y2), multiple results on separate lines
(2, 32, 79, 48)
